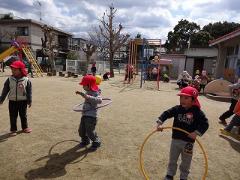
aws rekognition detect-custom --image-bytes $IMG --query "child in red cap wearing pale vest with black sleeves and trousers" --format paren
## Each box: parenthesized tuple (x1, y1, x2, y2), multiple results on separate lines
(0, 60, 32, 136)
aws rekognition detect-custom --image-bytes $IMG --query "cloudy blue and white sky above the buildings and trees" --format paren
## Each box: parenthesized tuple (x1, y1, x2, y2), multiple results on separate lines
(0, 0, 240, 41)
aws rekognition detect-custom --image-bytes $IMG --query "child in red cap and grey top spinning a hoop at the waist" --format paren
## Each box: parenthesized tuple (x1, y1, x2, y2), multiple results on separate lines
(76, 75, 102, 151)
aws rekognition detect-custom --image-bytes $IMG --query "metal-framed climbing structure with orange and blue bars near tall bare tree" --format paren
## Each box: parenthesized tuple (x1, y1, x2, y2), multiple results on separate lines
(124, 38, 172, 90)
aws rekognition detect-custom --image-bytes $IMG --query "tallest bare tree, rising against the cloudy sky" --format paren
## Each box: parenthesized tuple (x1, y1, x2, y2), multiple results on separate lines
(99, 4, 130, 77)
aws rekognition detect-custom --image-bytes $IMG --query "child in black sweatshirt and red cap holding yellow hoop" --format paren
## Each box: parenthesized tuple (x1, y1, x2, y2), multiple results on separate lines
(157, 86, 209, 180)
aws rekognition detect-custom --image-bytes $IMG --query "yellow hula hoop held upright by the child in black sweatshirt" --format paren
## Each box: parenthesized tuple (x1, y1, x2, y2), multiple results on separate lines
(139, 127, 208, 180)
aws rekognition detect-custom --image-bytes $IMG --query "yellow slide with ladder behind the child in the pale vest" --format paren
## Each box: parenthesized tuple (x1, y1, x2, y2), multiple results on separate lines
(0, 41, 43, 77)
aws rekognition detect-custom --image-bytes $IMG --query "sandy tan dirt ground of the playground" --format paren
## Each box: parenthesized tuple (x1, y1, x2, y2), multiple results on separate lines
(0, 71, 240, 180)
